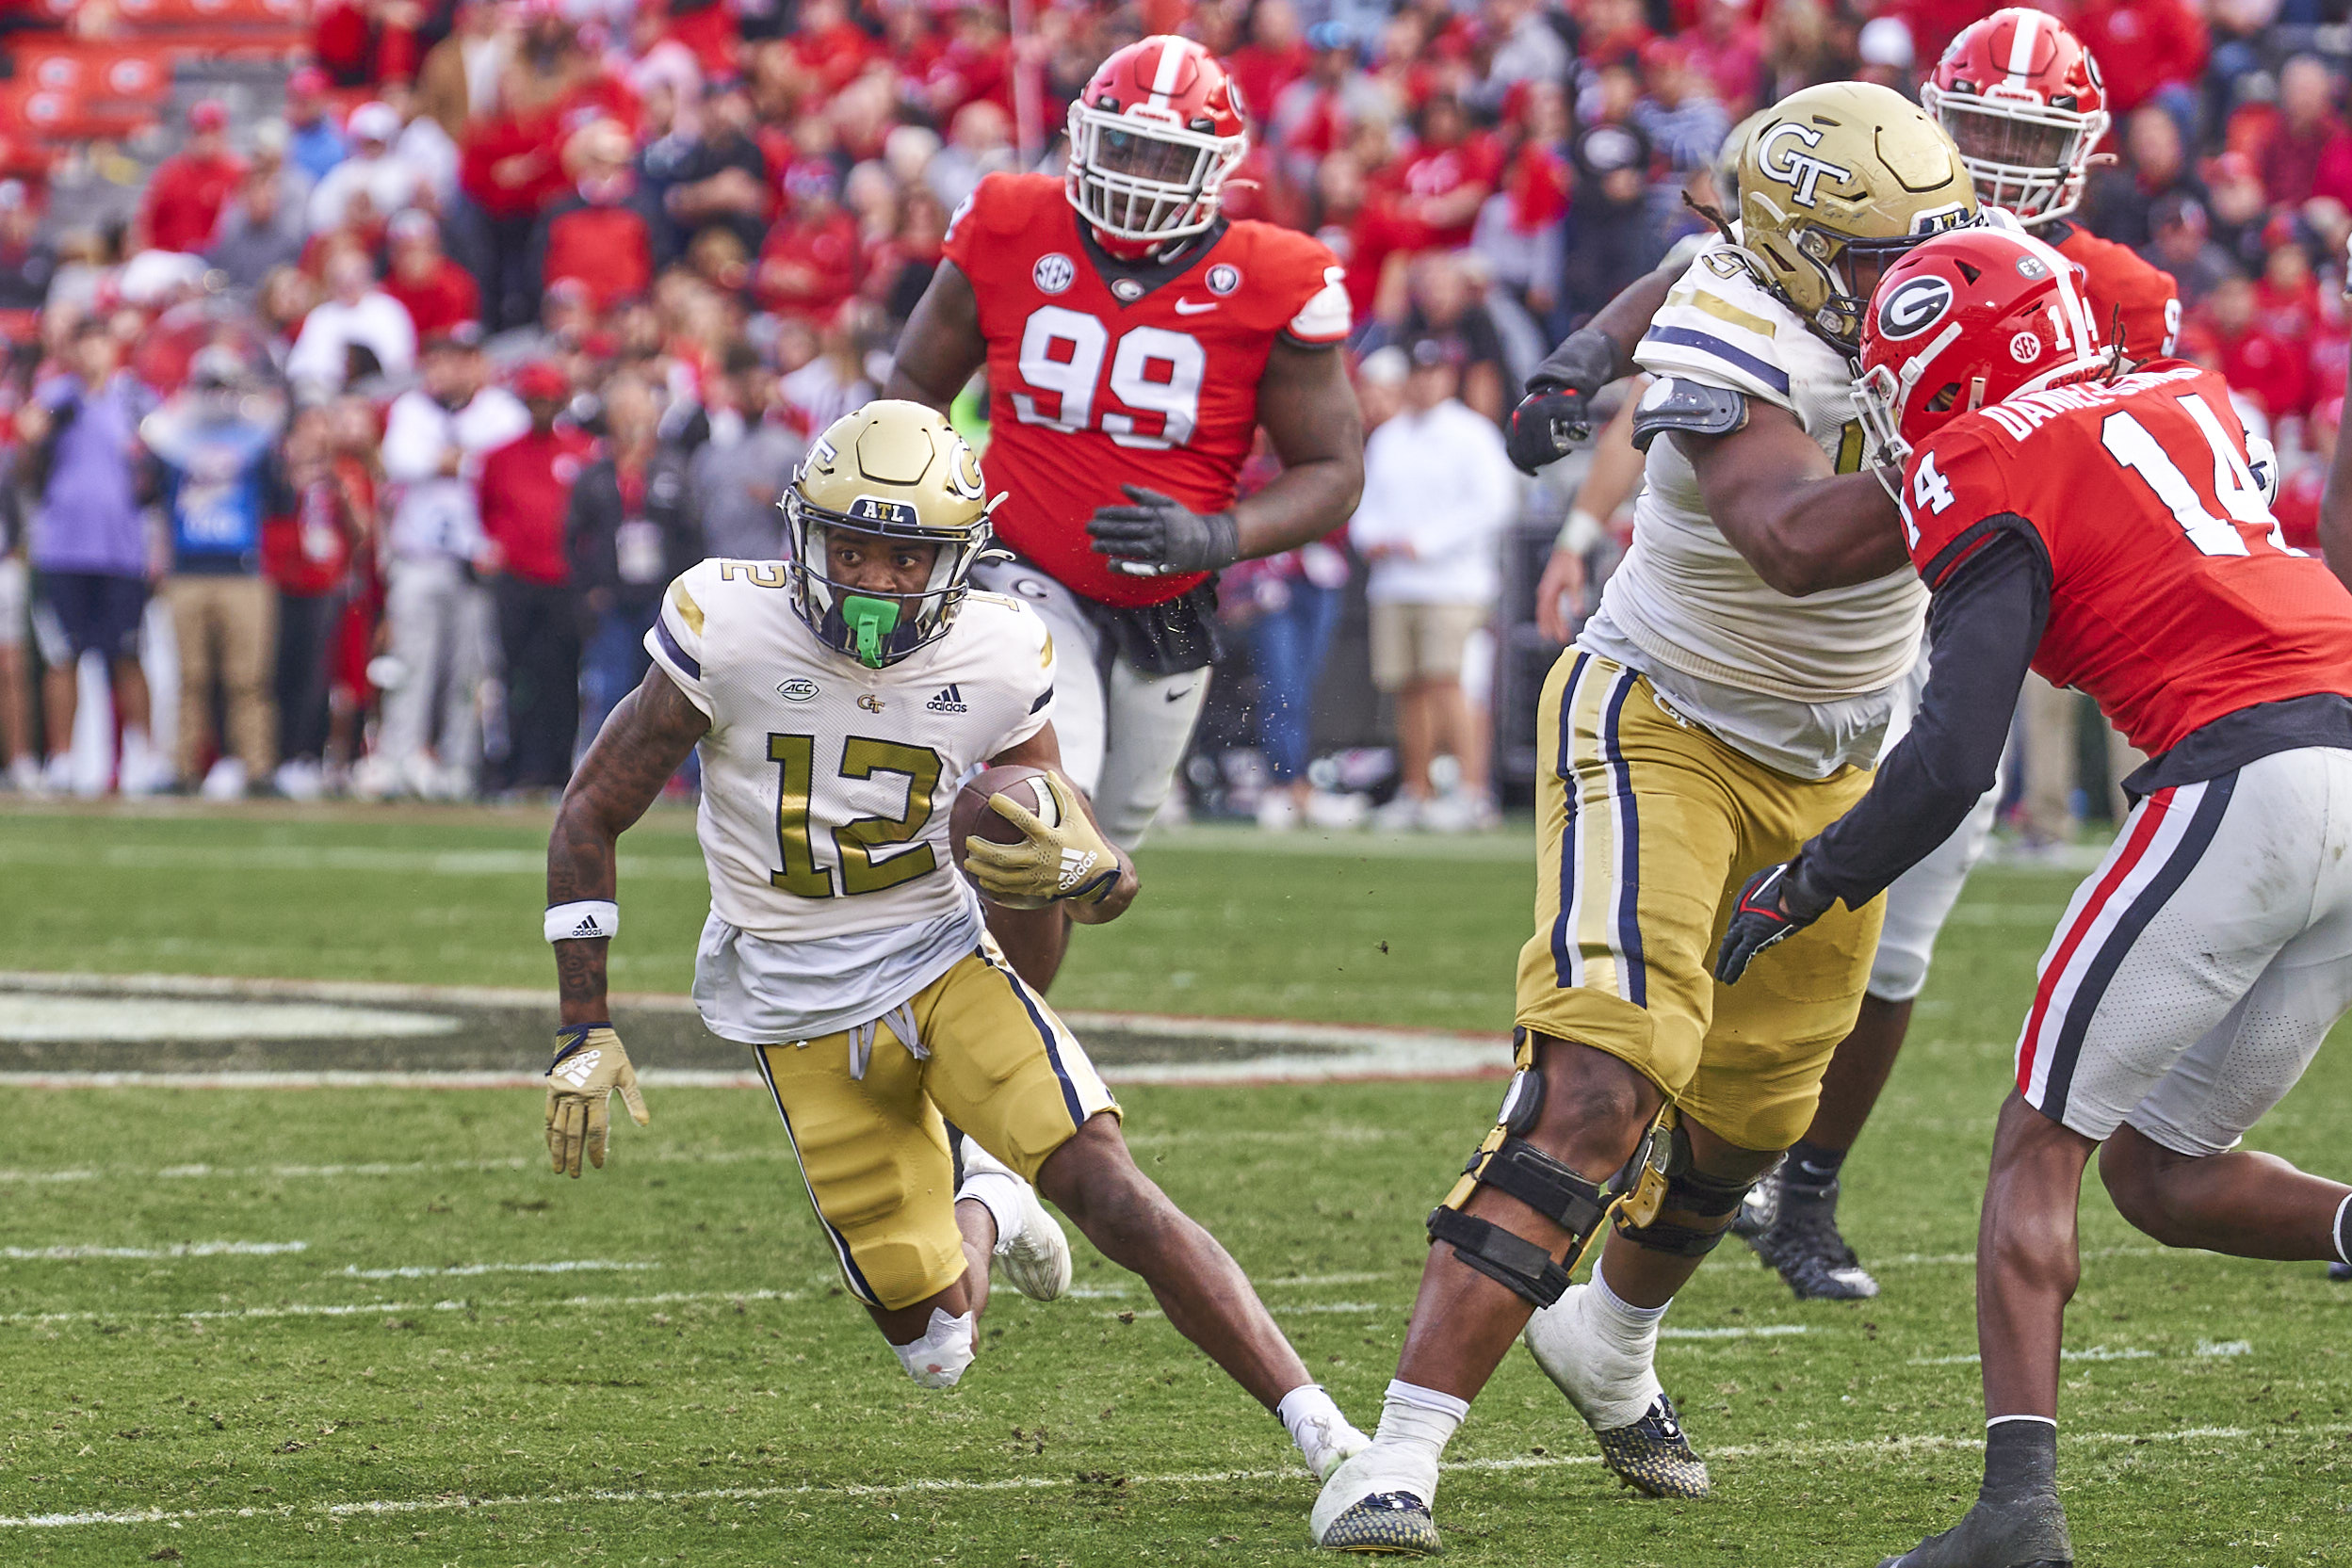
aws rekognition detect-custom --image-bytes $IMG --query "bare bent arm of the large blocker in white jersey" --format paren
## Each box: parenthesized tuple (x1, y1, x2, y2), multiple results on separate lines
(1670, 397, 1910, 600)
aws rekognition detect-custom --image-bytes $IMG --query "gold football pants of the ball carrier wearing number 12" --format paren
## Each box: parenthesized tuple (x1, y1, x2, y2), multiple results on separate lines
(755, 941, 1120, 1309)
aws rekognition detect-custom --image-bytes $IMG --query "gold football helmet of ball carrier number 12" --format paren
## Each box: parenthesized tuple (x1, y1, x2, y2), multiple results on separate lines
(779, 397, 1002, 670)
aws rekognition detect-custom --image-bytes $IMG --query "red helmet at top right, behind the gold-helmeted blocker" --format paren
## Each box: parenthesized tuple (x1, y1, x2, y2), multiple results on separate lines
(1920, 7, 2107, 223)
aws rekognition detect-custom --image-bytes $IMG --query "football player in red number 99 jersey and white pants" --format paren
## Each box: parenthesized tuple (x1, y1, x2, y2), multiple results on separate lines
(884, 35, 1364, 987)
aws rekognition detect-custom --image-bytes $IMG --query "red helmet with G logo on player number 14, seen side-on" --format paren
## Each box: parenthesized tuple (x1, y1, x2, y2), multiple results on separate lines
(1854, 228, 2115, 468)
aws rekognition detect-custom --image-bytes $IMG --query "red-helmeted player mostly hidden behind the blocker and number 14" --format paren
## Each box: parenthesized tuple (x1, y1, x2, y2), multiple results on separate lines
(1741, 7, 2181, 1298)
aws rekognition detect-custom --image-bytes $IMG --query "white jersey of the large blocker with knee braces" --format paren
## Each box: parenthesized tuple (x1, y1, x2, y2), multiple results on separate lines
(1590, 240, 1926, 776)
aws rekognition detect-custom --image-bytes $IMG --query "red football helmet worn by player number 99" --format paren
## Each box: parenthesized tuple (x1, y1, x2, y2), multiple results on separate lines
(1063, 33, 1249, 254)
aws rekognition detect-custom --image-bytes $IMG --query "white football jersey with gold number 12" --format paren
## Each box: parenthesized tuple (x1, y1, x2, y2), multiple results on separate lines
(644, 559, 1054, 963)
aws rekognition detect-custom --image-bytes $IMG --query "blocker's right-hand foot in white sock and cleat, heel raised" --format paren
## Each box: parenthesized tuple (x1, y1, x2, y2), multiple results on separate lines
(1519, 1285, 1712, 1497)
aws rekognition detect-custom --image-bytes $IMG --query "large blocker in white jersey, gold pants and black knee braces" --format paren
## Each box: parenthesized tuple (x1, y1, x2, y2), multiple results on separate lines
(1312, 82, 1978, 1552)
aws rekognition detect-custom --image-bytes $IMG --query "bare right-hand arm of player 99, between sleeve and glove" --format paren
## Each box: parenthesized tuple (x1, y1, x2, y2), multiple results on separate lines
(1232, 338, 1364, 562)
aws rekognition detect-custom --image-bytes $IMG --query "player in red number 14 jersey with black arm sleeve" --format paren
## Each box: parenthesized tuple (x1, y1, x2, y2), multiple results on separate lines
(1717, 231, 2352, 1568)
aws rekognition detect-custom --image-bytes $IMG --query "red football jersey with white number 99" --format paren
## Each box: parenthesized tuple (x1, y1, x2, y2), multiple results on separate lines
(946, 174, 1348, 605)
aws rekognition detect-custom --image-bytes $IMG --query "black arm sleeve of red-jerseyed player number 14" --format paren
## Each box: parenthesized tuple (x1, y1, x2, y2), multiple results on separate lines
(1799, 526, 2051, 910)
